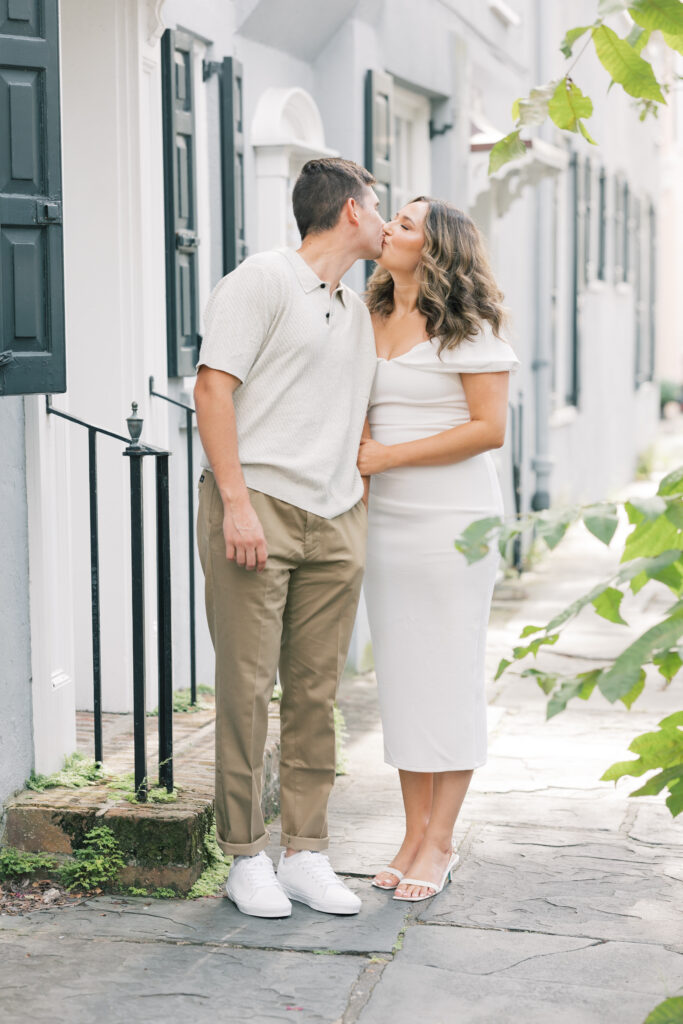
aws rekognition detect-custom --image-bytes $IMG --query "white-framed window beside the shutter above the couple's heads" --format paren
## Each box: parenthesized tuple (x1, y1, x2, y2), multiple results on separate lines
(391, 83, 431, 216)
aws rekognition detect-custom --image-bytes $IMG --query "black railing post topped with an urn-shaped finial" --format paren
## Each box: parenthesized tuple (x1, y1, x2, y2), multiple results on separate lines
(124, 402, 147, 803)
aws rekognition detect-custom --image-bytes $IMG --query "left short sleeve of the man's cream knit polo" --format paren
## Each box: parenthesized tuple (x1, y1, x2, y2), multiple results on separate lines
(197, 253, 284, 382)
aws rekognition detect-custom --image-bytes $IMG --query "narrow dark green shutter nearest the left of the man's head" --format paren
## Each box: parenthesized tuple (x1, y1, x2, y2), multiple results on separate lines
(220, 57, 247, 273)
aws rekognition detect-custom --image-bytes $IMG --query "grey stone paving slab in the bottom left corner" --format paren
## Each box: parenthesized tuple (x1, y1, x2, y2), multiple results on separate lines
(0, 934, 367, 1024)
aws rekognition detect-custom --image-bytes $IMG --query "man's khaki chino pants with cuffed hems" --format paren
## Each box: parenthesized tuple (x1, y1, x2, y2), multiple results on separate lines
(197, 470, 368, 855)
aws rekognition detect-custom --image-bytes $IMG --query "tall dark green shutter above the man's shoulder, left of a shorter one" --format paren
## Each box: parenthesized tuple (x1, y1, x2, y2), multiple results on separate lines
(162, 30, 199, 377)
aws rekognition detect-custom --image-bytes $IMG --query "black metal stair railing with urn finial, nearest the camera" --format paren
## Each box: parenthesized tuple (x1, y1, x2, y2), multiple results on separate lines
(46, 395, 173, 802)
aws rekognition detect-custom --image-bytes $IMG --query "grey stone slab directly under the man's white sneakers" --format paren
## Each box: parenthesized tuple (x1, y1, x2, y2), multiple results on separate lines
(0, 880, 408, 954)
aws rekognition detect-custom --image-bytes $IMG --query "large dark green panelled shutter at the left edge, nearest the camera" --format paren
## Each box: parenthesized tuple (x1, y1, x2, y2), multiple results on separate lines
(0, 0, 67, 394)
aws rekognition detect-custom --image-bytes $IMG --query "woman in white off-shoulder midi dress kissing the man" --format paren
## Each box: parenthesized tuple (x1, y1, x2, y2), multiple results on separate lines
(358, 196, 518, 901)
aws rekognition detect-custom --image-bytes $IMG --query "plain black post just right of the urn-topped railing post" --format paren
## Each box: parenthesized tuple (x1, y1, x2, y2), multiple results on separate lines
(156, 455, 173, 793)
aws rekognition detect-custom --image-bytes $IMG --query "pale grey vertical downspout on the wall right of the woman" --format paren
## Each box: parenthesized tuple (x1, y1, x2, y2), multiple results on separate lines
(531, 0, 555, 512)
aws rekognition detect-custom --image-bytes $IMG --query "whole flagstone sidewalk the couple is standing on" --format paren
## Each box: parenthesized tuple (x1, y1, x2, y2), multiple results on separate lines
(0, 483, 683, 1024)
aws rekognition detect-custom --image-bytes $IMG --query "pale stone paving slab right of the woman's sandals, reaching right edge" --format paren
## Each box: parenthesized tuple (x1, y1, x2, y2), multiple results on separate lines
(419, 825, 683, 944)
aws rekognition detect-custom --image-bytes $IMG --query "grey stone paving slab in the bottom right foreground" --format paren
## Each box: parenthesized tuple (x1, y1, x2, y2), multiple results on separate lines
(358, 927, 683, 1024)
